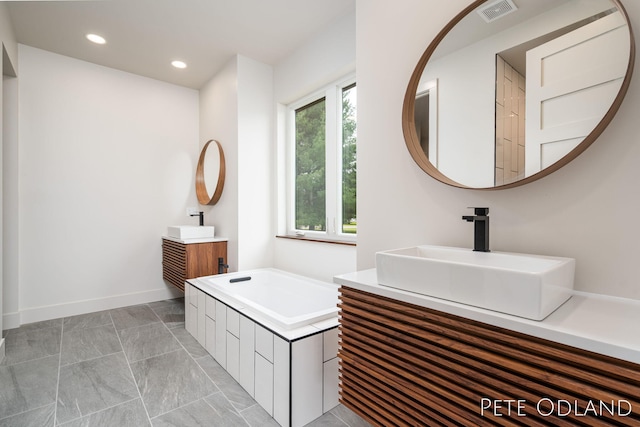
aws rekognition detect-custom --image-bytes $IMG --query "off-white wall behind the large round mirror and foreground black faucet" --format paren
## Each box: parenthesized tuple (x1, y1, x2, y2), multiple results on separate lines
(356, 0, 640, 299)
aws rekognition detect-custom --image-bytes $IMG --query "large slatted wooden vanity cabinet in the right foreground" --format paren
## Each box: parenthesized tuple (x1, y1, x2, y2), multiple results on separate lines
(339, 286, 640, 426)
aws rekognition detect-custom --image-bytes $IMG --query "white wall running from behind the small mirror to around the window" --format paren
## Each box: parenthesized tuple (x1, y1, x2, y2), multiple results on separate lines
(200, 13, 356, 281)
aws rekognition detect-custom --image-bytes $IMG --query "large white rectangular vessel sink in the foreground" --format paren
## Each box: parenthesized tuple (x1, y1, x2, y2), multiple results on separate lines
(376, 245, 575, 320)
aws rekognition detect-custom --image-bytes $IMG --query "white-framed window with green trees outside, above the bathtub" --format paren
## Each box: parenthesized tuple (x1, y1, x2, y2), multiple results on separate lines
(287, 80, 357, 240)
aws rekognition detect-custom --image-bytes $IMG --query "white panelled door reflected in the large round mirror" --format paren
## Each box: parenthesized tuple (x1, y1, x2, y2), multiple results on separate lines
(525, 12, 629, 176)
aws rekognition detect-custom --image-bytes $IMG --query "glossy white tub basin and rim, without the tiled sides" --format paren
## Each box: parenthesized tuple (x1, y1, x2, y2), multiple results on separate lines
(190, 268, 339, 330)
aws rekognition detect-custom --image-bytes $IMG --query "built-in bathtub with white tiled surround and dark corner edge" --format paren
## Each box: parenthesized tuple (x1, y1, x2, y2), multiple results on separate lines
(185, 268, 339, 427)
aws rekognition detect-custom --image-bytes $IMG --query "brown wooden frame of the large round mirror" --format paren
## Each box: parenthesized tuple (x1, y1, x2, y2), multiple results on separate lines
(402, 0, 635, 190)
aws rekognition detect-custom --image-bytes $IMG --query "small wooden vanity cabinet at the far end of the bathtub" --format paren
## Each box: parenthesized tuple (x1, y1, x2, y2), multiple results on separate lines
(162, 238, 227, 292)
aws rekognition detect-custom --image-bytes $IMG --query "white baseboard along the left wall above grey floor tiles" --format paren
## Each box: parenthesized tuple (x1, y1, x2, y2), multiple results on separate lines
(12, 287, 184, 328)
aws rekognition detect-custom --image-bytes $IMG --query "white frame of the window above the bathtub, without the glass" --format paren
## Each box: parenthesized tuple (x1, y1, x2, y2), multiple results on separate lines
(285, 74, 357, 243)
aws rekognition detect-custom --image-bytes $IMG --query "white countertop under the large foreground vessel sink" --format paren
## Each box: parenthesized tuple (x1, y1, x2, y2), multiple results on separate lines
(333, 268, 640, 363)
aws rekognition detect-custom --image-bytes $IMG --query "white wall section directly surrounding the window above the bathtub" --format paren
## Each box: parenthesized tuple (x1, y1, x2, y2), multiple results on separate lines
(274, 12, 360, 281)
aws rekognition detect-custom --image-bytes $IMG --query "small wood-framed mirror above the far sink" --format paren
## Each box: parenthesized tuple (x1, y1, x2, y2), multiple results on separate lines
(196, 139, 226, 205)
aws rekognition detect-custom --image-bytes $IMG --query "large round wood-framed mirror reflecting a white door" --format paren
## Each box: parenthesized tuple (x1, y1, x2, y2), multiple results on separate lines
(402, 0, 635, 189)
